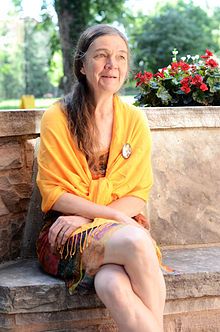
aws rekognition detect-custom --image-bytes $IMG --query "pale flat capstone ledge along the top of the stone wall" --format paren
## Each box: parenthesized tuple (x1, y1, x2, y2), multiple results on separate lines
(0, 106, 220, 137)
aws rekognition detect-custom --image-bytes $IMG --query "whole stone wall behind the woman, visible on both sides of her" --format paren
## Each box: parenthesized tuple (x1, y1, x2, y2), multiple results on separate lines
(0, 107, 220, 261)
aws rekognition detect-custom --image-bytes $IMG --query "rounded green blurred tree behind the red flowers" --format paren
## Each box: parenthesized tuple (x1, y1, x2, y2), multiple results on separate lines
(132, 0, 217, 71)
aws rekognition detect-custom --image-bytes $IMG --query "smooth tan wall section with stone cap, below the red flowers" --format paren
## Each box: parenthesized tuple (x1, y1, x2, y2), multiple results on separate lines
(144, 106, 220, 246)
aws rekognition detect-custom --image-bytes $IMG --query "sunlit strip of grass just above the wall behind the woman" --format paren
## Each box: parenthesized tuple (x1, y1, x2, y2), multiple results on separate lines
(0, 95, 134, 110)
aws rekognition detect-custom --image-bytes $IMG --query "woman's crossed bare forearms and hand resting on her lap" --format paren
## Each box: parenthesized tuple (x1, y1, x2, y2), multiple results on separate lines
(48, 193, 144, 248)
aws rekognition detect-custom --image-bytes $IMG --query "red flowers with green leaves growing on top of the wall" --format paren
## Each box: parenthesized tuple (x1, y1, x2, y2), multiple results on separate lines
(135, 49, 220, 107)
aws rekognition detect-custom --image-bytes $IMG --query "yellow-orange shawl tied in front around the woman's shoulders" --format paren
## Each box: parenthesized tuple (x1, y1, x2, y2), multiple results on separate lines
(37, 96, 153, 231)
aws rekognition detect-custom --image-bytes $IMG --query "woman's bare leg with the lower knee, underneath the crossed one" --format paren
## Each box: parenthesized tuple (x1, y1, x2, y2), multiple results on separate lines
(95, 264, 163, 332)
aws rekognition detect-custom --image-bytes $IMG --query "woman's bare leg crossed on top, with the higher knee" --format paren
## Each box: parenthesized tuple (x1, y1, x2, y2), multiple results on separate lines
(100, 225, 166, 332)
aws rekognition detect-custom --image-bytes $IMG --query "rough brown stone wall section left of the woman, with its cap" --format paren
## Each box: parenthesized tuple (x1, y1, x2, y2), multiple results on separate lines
(0, 110, 42, 262)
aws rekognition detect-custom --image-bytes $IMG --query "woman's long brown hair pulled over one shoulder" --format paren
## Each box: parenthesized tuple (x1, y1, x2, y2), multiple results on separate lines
(62, 24, 129, 157)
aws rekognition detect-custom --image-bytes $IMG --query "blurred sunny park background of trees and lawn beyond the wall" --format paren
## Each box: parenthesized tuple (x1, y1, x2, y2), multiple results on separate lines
(0, 0, 220, 109)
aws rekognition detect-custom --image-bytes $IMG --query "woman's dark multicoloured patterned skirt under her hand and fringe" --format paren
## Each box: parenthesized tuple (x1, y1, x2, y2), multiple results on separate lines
(36, 211, 164, 294)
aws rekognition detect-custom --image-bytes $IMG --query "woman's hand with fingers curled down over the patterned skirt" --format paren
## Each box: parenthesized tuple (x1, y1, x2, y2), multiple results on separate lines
(48, 216, 91, 249)
